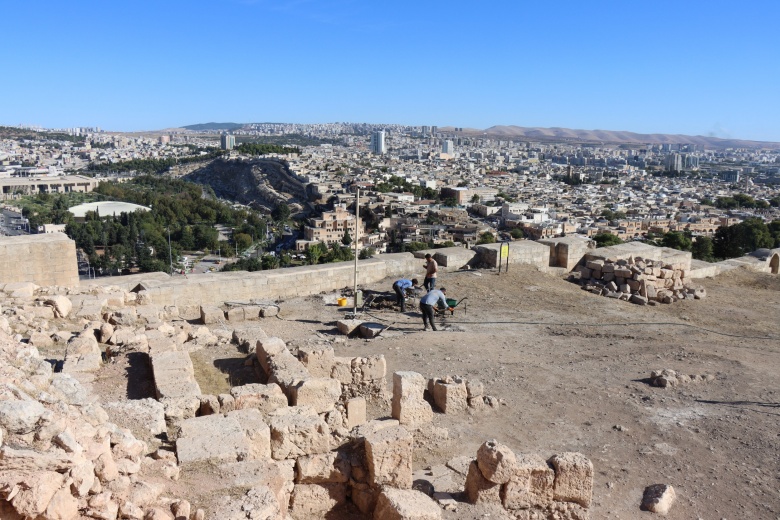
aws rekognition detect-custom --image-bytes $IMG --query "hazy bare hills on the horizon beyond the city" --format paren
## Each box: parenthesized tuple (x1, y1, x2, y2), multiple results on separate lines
(181, 123, 780, 149)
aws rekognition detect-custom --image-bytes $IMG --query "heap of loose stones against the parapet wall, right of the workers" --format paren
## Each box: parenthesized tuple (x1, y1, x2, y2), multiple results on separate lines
(577, 256, 706, 305)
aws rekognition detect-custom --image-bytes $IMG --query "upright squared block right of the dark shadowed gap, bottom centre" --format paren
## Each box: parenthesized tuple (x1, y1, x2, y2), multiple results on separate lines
(365, 425, 413, 489)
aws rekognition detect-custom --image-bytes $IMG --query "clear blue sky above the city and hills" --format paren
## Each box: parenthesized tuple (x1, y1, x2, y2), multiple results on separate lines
(0, 0, 780, 141)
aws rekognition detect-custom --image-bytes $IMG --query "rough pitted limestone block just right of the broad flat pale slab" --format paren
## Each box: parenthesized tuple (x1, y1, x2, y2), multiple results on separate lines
(269, 407, 330, 460)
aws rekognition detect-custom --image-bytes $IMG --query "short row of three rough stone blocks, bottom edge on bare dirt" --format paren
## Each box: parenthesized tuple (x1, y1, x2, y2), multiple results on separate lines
(466, 440, 593, 520)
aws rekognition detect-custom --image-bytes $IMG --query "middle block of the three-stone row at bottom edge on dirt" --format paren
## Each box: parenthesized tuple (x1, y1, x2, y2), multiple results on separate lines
(501, 454, 555, 509)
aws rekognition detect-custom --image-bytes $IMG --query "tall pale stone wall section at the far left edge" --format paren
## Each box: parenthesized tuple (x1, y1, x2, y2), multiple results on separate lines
(0, 233, 79, 287)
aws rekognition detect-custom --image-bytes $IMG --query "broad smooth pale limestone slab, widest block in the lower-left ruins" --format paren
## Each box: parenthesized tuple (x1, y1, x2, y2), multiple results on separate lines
(176, 415, 252, 464)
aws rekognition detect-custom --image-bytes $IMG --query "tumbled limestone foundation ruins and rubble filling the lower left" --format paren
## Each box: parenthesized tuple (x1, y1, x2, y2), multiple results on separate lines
(0, 284, 593, 520)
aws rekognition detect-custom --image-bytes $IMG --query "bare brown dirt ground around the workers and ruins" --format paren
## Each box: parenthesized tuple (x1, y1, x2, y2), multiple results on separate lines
(100, 266, 780, 520)
